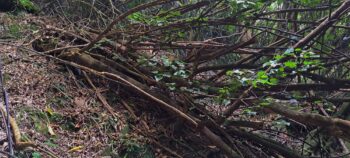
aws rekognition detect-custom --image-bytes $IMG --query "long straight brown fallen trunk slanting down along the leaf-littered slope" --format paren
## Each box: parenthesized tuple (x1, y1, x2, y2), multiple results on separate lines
(55, 49, 240, 157)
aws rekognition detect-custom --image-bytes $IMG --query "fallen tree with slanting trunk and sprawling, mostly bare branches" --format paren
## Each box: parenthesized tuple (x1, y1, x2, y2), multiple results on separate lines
(13, 0, 350, 157)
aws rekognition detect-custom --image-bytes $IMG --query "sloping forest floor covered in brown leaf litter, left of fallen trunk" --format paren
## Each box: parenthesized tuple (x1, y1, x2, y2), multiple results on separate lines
(0, 13, 158, 157)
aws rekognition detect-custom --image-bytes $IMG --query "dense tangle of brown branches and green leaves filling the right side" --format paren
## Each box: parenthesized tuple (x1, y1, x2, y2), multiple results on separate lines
(9, 0, 350, 158)
